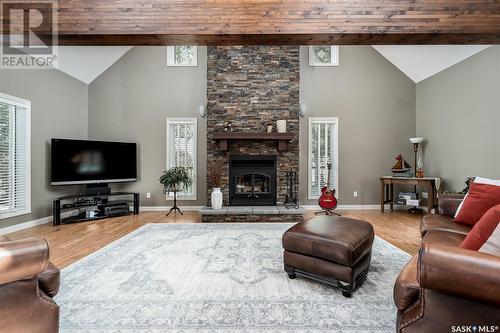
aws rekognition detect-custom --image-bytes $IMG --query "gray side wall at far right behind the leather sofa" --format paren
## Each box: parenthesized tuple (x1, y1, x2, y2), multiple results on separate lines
(417, 46, 500, 190)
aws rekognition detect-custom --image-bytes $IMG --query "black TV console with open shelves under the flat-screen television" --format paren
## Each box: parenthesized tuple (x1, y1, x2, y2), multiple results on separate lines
(52, 192, 139, 226)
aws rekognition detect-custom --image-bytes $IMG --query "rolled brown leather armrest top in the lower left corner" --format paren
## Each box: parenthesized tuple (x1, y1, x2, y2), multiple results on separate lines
(0, 238, 49, 284)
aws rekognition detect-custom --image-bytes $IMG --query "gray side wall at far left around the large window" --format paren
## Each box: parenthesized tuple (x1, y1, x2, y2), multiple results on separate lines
(0, 70, 88, 227)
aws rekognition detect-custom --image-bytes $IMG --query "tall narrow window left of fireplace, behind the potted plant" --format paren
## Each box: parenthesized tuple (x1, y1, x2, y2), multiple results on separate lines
(167, 118, 197, 200)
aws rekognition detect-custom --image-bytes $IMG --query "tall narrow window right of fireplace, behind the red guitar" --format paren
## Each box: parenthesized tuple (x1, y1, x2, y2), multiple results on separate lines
(308, 117, 339, 199)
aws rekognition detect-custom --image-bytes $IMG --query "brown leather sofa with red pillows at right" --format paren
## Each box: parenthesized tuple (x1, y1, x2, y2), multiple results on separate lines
(394, 195, 500, 333)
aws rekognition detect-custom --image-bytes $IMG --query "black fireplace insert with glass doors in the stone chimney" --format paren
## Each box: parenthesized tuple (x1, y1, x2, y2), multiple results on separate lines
(229, 155, 276, 206)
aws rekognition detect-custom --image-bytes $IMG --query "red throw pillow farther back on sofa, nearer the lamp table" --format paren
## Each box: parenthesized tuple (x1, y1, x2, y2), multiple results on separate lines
(455, 182, 500, 226)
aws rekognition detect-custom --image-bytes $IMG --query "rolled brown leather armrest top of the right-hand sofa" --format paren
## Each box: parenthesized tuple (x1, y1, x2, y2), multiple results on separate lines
(418, 242, 500, 306)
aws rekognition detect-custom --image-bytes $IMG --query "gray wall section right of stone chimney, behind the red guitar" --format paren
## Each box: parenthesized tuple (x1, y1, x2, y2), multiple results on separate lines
(300, 46, 415, 205)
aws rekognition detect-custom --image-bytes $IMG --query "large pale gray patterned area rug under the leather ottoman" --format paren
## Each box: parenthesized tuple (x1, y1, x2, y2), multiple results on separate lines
(56, 223, 409, 333)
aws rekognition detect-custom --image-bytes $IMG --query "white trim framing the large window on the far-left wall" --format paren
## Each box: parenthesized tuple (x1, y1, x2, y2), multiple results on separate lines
(0, 93, 31, 219)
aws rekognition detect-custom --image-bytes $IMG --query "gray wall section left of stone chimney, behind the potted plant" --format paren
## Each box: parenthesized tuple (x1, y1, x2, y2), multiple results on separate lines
(88, 47, 207, 206)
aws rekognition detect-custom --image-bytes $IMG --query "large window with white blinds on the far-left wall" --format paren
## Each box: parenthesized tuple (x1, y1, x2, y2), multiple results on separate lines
(0, 93, 31, 218)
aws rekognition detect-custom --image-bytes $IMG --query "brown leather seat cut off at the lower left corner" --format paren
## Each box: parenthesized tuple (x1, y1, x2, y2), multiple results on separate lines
(0, 236, 60, 333)
